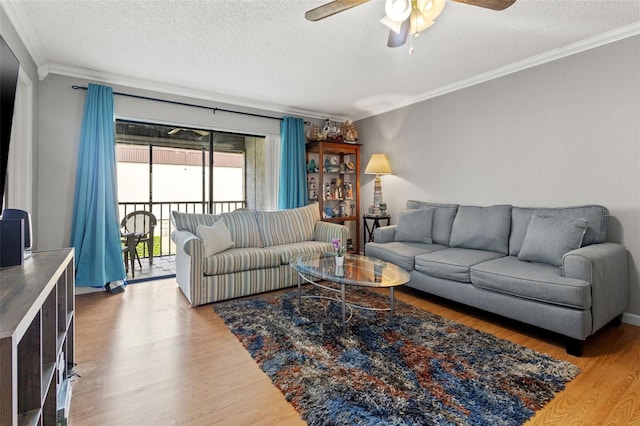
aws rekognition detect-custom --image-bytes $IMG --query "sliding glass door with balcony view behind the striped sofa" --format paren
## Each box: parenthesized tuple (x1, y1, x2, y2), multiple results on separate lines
(116, 121, 255, 257)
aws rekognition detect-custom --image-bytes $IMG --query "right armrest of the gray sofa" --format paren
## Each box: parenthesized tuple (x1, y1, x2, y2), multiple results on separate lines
(562, 243, 629, 333)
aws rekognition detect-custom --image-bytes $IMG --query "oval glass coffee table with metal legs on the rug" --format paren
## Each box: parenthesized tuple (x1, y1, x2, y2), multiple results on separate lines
(290, 253, 410, 332)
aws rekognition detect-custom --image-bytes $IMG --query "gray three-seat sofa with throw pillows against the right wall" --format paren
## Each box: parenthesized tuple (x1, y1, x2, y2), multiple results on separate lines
(365, 200, 628, 356)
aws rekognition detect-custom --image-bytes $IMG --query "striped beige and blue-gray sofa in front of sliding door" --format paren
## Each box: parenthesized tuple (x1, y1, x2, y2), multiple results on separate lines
(171, 204, 348, 306)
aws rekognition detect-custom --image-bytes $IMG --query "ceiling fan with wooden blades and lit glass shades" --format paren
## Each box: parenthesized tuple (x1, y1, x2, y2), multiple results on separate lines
(304, 0, 516, 53)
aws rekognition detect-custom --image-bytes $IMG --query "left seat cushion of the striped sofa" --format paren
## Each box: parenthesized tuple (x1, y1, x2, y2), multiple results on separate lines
(202, 247, 280, 275)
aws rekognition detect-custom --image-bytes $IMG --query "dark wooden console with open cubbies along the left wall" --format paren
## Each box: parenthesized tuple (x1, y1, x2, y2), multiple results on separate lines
(0, 248, 75, 426)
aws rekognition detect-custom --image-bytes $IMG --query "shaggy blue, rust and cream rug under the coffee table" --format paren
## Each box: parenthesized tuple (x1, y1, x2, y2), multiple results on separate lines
(214, 286, 580, 425)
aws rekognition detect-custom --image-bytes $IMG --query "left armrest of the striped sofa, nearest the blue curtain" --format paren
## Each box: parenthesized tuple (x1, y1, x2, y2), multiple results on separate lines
(171, 230, 204, 306)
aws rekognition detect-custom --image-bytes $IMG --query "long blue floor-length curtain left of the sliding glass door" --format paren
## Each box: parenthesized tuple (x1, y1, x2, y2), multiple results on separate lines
(71, 84, 126, 287)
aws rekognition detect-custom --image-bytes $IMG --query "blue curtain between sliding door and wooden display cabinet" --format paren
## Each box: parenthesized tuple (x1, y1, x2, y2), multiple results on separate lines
(278, 117, 307, 210)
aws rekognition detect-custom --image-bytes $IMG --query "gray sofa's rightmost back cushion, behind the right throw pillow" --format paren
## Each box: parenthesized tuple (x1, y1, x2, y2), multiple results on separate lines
(509, 205, 609, 256)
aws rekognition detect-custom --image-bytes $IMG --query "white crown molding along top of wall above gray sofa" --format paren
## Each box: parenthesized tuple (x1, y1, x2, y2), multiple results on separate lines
(354, 22, 640, 121)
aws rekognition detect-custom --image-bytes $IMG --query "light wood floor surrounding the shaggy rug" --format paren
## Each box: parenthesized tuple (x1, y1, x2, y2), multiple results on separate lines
(69, 279, 640, 426)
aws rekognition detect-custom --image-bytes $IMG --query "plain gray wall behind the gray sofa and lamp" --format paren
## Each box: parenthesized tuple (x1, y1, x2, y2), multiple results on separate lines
(356, 36, 640, 321)
